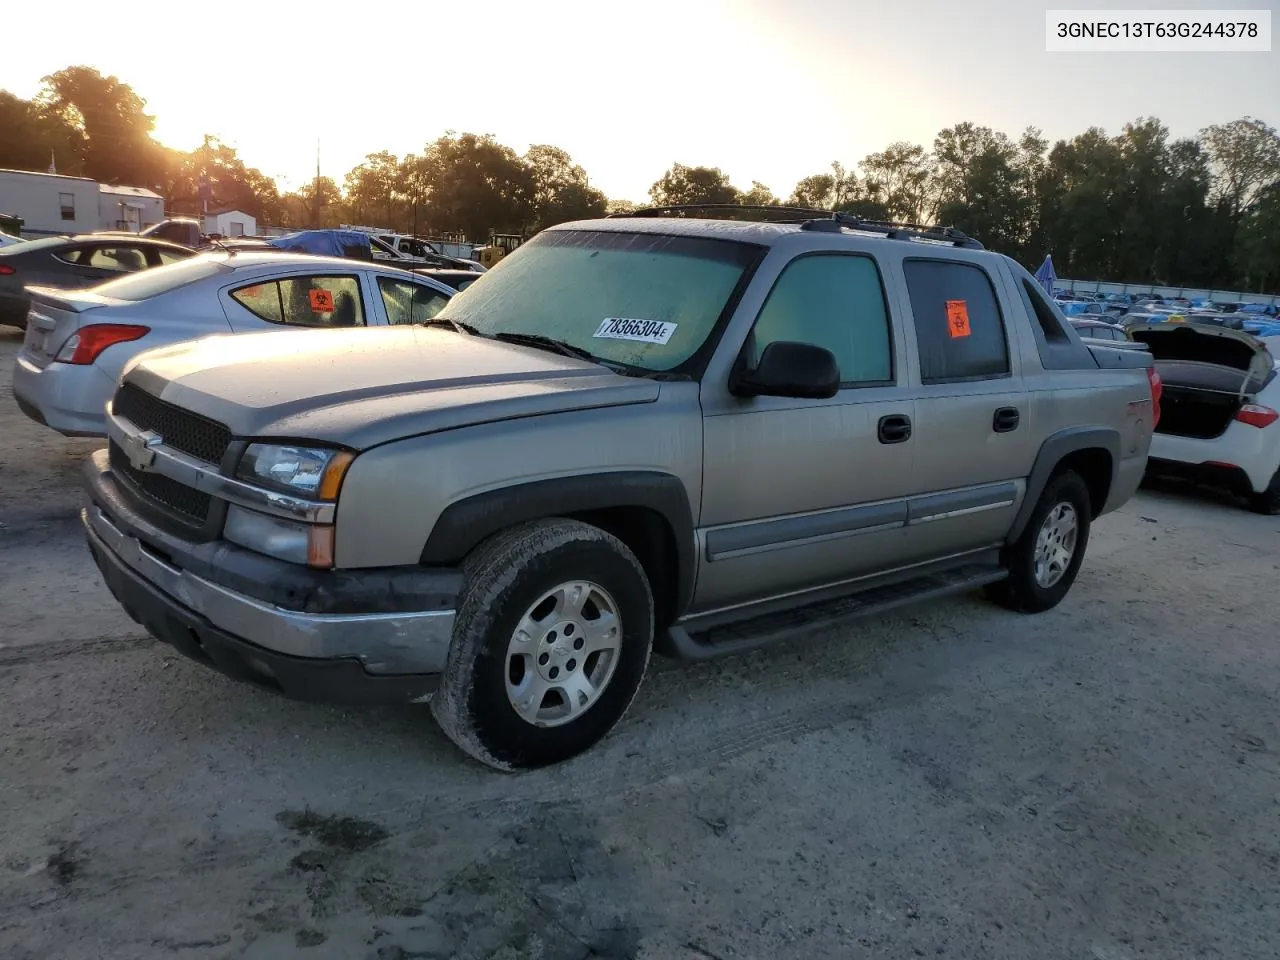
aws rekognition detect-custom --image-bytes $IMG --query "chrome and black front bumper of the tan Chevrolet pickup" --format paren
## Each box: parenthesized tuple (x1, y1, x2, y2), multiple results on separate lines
(81, 452, 461, 703)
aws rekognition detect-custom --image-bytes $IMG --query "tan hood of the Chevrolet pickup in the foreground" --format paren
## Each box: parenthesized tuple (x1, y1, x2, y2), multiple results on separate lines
(124, 326, 659, 449)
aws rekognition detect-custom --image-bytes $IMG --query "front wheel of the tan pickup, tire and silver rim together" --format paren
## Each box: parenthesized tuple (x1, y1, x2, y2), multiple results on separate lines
(431, 520, 653, 769)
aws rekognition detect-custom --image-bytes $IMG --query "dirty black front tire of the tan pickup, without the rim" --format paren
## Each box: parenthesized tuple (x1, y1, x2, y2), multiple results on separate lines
(431, 518, 653, 771)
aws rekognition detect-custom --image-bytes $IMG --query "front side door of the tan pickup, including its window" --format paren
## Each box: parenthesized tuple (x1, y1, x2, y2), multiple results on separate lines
(691, 253, 918, 613)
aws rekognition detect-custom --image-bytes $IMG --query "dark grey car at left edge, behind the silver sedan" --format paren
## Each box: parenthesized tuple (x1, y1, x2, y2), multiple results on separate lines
(0, 233, 196, 329)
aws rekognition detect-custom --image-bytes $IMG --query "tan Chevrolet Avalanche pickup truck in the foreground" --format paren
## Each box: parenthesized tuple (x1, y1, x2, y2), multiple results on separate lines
(82, 215, 1157, 769)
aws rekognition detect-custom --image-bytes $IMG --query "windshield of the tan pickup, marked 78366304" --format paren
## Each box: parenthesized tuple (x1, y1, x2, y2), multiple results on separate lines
(444, 230, 760, 371)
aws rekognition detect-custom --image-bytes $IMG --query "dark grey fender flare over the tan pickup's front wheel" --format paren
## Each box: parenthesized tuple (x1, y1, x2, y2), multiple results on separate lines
(421, 470, 698, 612)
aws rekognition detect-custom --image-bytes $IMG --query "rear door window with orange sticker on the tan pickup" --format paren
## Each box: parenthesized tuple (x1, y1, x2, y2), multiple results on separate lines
(902, 260, 1009, 383)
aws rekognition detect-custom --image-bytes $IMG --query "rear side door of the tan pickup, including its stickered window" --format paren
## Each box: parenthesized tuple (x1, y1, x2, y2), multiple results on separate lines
(901, 257, 1037, 558)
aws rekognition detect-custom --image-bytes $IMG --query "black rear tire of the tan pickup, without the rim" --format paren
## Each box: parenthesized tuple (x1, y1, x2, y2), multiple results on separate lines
(986, 471, 1092, 613)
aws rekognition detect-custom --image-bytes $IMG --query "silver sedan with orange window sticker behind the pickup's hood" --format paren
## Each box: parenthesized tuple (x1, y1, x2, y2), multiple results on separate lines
(13, 251, 454, 436)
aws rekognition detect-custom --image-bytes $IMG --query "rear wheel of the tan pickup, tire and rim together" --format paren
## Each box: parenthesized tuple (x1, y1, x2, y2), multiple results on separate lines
(987, 471, 1091, 613)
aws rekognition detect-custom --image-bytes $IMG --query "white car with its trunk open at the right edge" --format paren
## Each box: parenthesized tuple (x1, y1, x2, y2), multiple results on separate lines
(1128, 323, 1280, 513)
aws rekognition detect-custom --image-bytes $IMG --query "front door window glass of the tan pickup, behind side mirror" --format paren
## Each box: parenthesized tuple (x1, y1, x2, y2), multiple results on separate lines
(748, 253, 893, 385)
